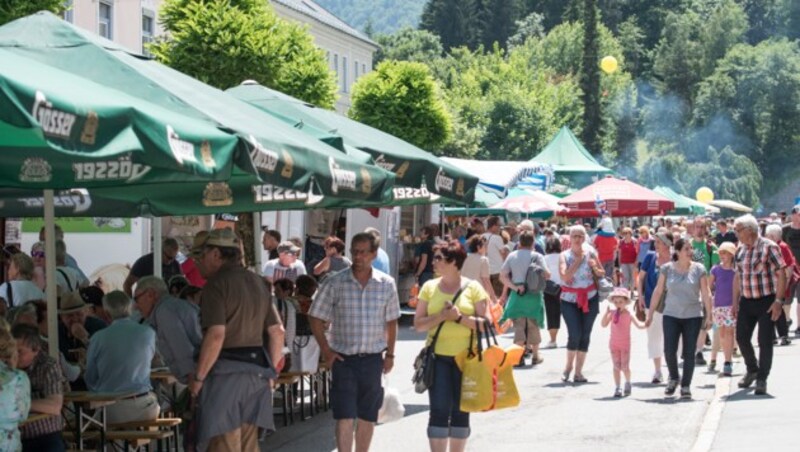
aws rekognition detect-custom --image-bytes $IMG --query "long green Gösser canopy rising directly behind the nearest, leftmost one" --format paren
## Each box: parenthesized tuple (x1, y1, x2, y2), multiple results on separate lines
(0, 12, 395, 202)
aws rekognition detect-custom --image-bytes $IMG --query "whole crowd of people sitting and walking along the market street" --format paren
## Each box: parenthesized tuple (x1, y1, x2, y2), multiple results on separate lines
(0, 206, 800, 451)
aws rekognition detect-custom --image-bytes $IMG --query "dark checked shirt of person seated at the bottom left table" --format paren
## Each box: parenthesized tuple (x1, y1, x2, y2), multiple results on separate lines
(19, 350, 64, 439)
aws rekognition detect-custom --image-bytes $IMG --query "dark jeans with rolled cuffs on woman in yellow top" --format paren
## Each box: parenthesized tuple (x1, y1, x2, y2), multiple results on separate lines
(428, 355, 469, 439)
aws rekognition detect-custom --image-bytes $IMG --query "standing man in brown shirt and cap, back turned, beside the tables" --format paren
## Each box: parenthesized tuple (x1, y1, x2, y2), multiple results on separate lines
(189, 229, 284, 452)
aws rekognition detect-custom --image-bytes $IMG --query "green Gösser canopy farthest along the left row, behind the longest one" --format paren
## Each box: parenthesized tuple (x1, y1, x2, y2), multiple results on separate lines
(226, 83, 478, 203)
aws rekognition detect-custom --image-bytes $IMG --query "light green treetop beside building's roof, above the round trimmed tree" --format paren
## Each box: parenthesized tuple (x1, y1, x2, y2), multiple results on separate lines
(373, 28, 444, 65)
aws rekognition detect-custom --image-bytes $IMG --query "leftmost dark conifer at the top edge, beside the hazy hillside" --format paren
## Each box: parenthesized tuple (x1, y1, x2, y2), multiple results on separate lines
(419, 0, 479, 50)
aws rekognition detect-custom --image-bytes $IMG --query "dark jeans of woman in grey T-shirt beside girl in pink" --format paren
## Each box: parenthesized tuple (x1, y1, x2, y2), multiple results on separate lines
(663, 315, 703, 388)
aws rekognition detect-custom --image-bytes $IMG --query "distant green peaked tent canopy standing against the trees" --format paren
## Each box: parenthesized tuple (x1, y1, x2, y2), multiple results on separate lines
(530, 126, 613, 176)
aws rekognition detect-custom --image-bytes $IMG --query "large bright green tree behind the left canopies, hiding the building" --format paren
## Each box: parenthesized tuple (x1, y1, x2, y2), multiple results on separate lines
(150, 0, 337, 108)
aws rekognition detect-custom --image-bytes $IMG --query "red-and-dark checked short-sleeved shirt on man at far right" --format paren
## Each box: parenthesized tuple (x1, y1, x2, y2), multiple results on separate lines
(736, 237, 786, 299)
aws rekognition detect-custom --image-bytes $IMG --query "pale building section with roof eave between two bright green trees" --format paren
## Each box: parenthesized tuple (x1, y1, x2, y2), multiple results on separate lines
(271, 0, 379, 113)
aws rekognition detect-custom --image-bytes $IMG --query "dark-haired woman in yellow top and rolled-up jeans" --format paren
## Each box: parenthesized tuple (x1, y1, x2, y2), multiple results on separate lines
(414, 240, 489, 452)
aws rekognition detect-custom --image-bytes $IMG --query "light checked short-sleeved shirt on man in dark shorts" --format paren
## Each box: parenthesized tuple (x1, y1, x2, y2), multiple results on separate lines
(308, 269, 400, 355)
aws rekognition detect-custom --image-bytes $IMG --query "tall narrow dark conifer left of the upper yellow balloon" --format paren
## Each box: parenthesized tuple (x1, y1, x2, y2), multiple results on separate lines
(581, 0, 600, 152)
